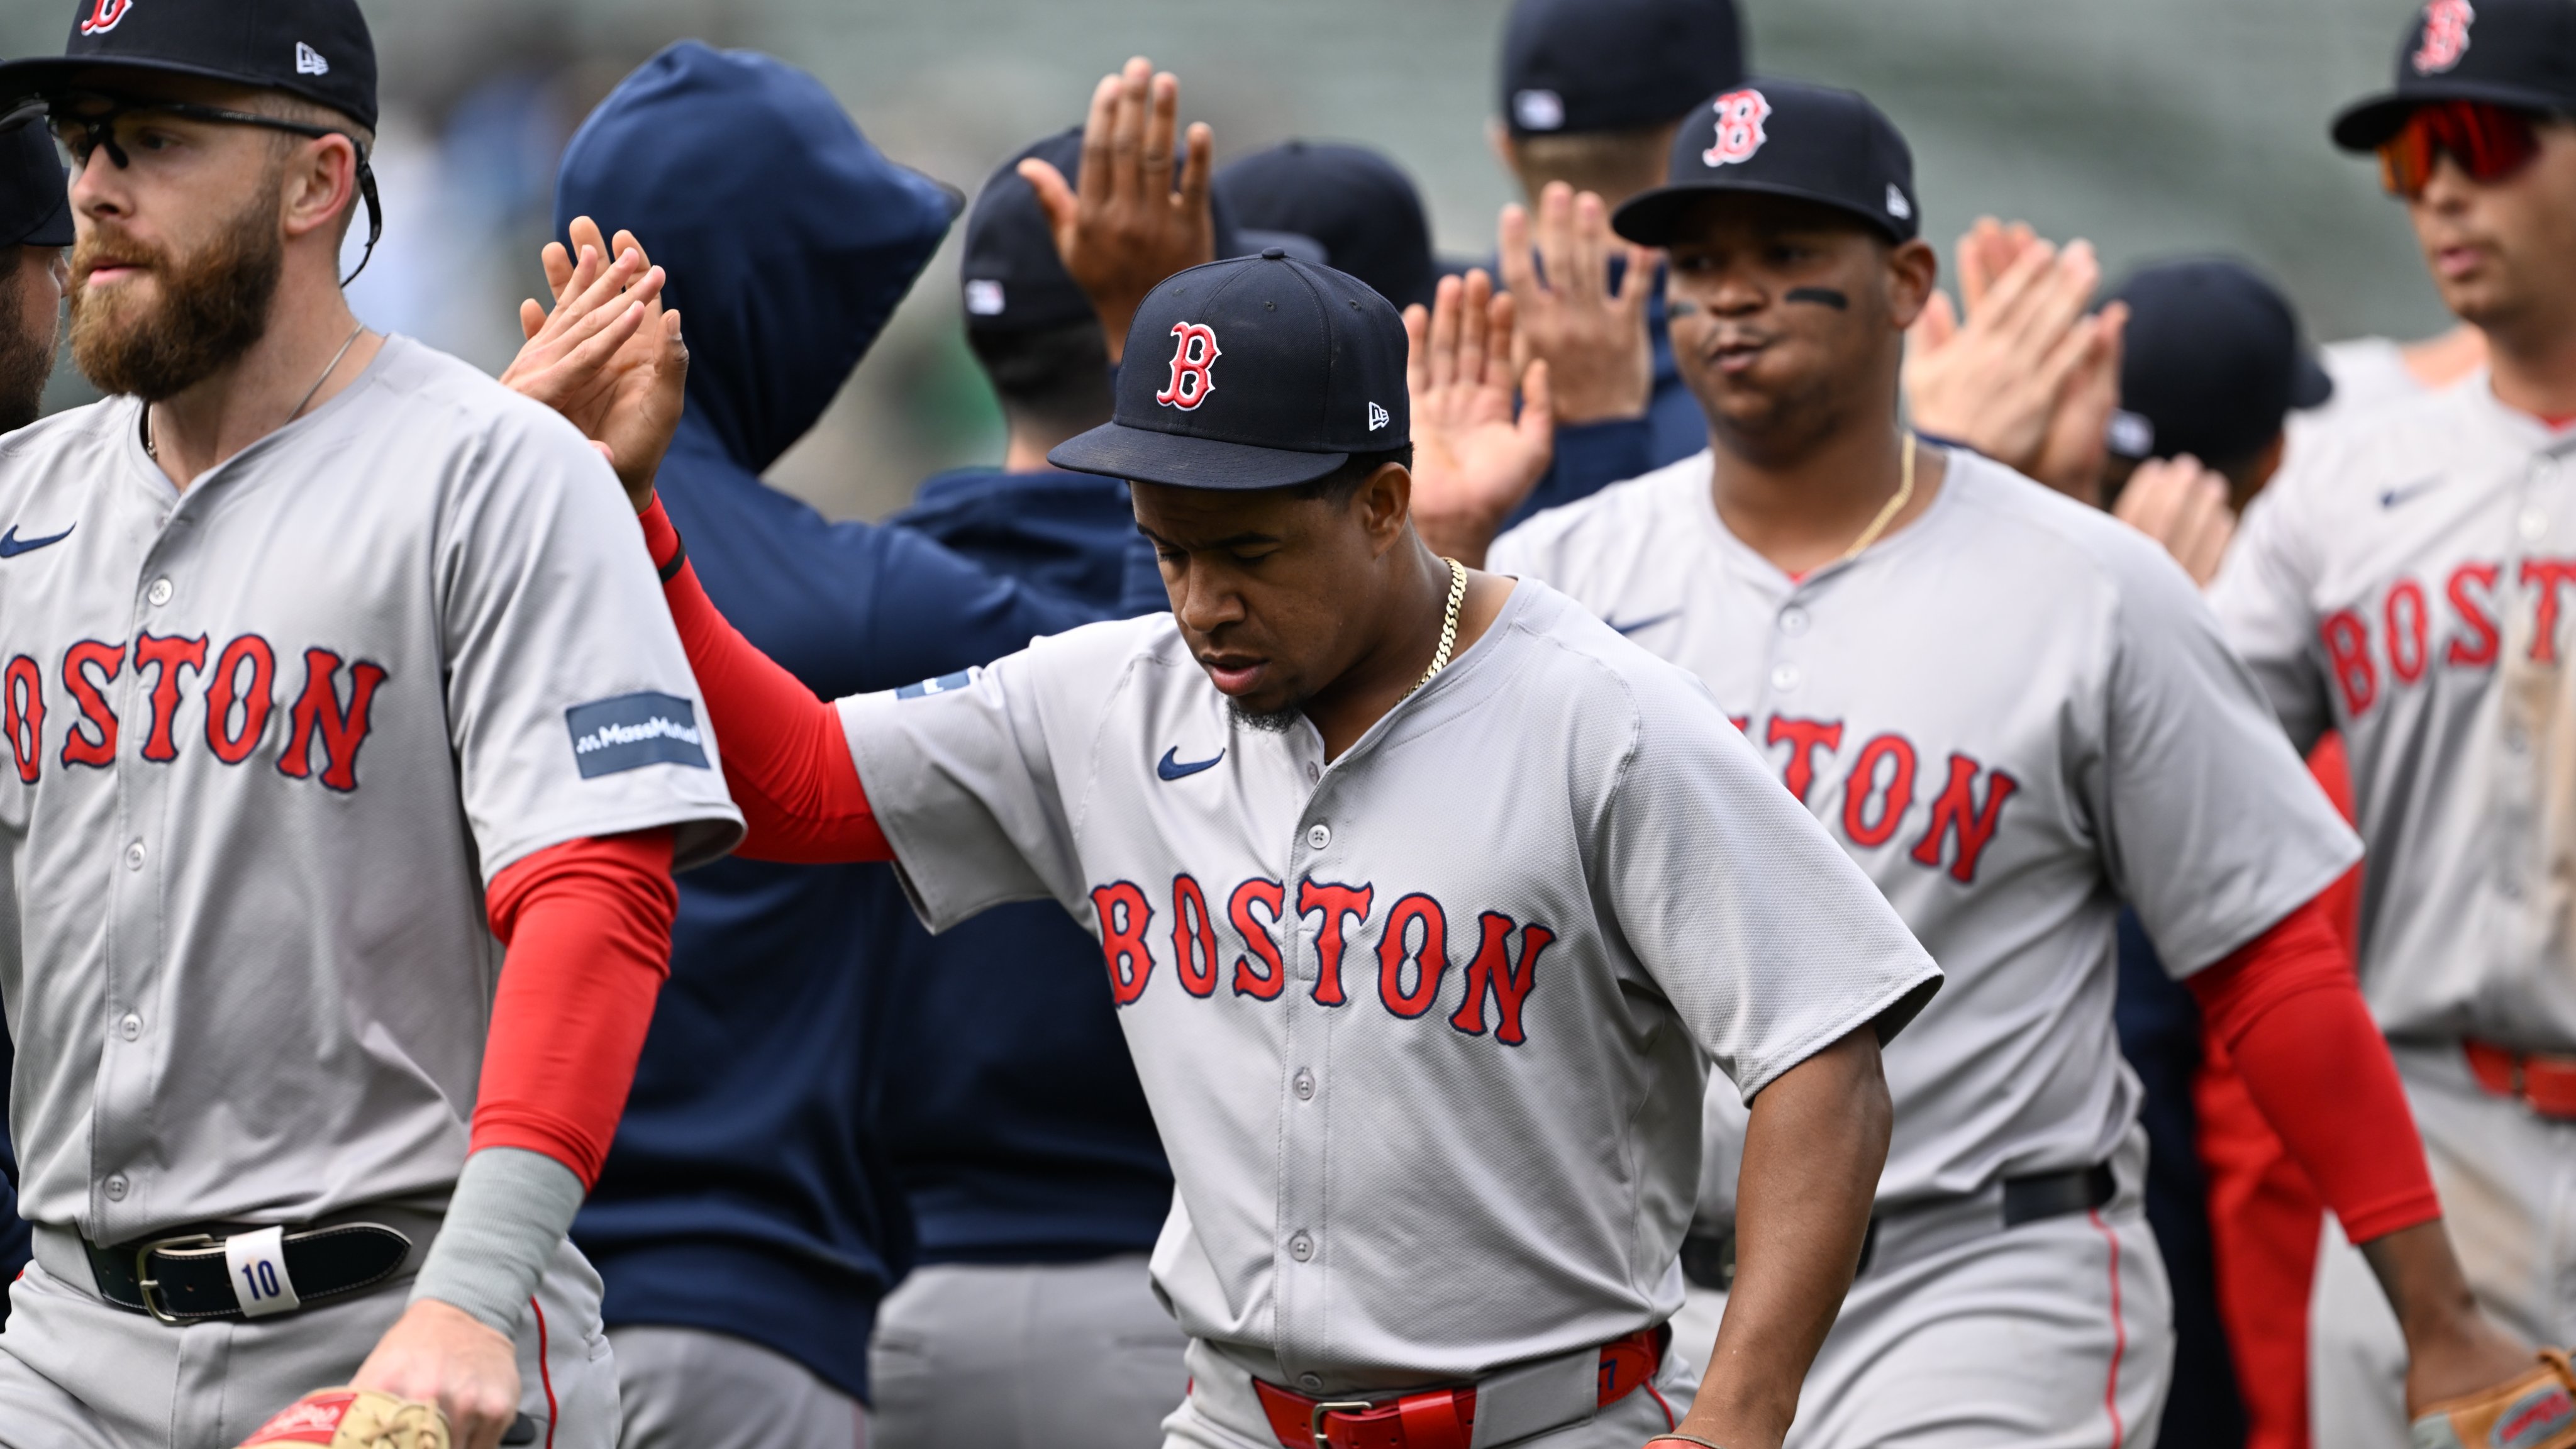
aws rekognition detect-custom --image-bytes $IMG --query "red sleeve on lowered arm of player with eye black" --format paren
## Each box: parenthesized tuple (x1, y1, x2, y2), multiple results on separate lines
(2190, 897, 2442, 1243)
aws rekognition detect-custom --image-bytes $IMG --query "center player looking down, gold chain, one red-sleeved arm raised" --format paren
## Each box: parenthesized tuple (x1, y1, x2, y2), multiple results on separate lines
(558, 237, 1937, 1449)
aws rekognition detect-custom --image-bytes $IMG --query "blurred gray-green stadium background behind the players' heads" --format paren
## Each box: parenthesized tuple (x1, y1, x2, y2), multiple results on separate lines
(0, 0, 2447, 518)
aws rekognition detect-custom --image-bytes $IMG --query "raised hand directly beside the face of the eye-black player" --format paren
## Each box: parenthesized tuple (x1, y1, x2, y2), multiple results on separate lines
(1499, 180, 1657, 425)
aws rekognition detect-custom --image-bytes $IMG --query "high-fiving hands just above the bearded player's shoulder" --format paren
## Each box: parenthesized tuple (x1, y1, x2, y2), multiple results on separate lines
(500, 216, 688, 511)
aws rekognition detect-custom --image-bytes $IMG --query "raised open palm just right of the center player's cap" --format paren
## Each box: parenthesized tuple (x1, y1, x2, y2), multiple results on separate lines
(1404, 270, 1556, 567)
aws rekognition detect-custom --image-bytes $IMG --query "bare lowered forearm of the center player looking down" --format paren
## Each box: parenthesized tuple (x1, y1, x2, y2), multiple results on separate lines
(1682, 1026, 1896, 1449)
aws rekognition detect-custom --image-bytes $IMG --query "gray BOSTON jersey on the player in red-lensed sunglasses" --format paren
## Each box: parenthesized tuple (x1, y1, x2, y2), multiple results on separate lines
(2210, 371, 2576, 1052)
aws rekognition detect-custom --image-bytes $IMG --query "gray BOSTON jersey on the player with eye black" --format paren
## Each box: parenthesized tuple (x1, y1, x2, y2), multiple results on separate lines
(1492, 451, 2355, 1204)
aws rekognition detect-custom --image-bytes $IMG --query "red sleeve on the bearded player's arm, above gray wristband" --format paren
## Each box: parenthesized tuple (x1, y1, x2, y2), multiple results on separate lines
(472, 828, 680, 1189)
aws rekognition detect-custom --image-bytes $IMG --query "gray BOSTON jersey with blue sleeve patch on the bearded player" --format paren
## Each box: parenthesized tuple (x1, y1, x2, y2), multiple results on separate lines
(0, 338, 740, 1243)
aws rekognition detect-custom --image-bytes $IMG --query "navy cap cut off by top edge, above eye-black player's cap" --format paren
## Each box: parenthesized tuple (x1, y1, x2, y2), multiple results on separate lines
(1502, 0, 1744, 136)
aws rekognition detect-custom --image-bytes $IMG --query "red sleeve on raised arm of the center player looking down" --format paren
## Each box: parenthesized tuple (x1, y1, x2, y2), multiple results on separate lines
(641, 497, 894, 863)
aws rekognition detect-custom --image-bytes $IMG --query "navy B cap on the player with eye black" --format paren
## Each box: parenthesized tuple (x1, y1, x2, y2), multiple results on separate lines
(1610, 80, 1922, 248)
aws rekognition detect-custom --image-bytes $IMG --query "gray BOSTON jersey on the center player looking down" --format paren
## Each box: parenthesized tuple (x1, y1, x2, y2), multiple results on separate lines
(840, 586, 1937, 1392)
